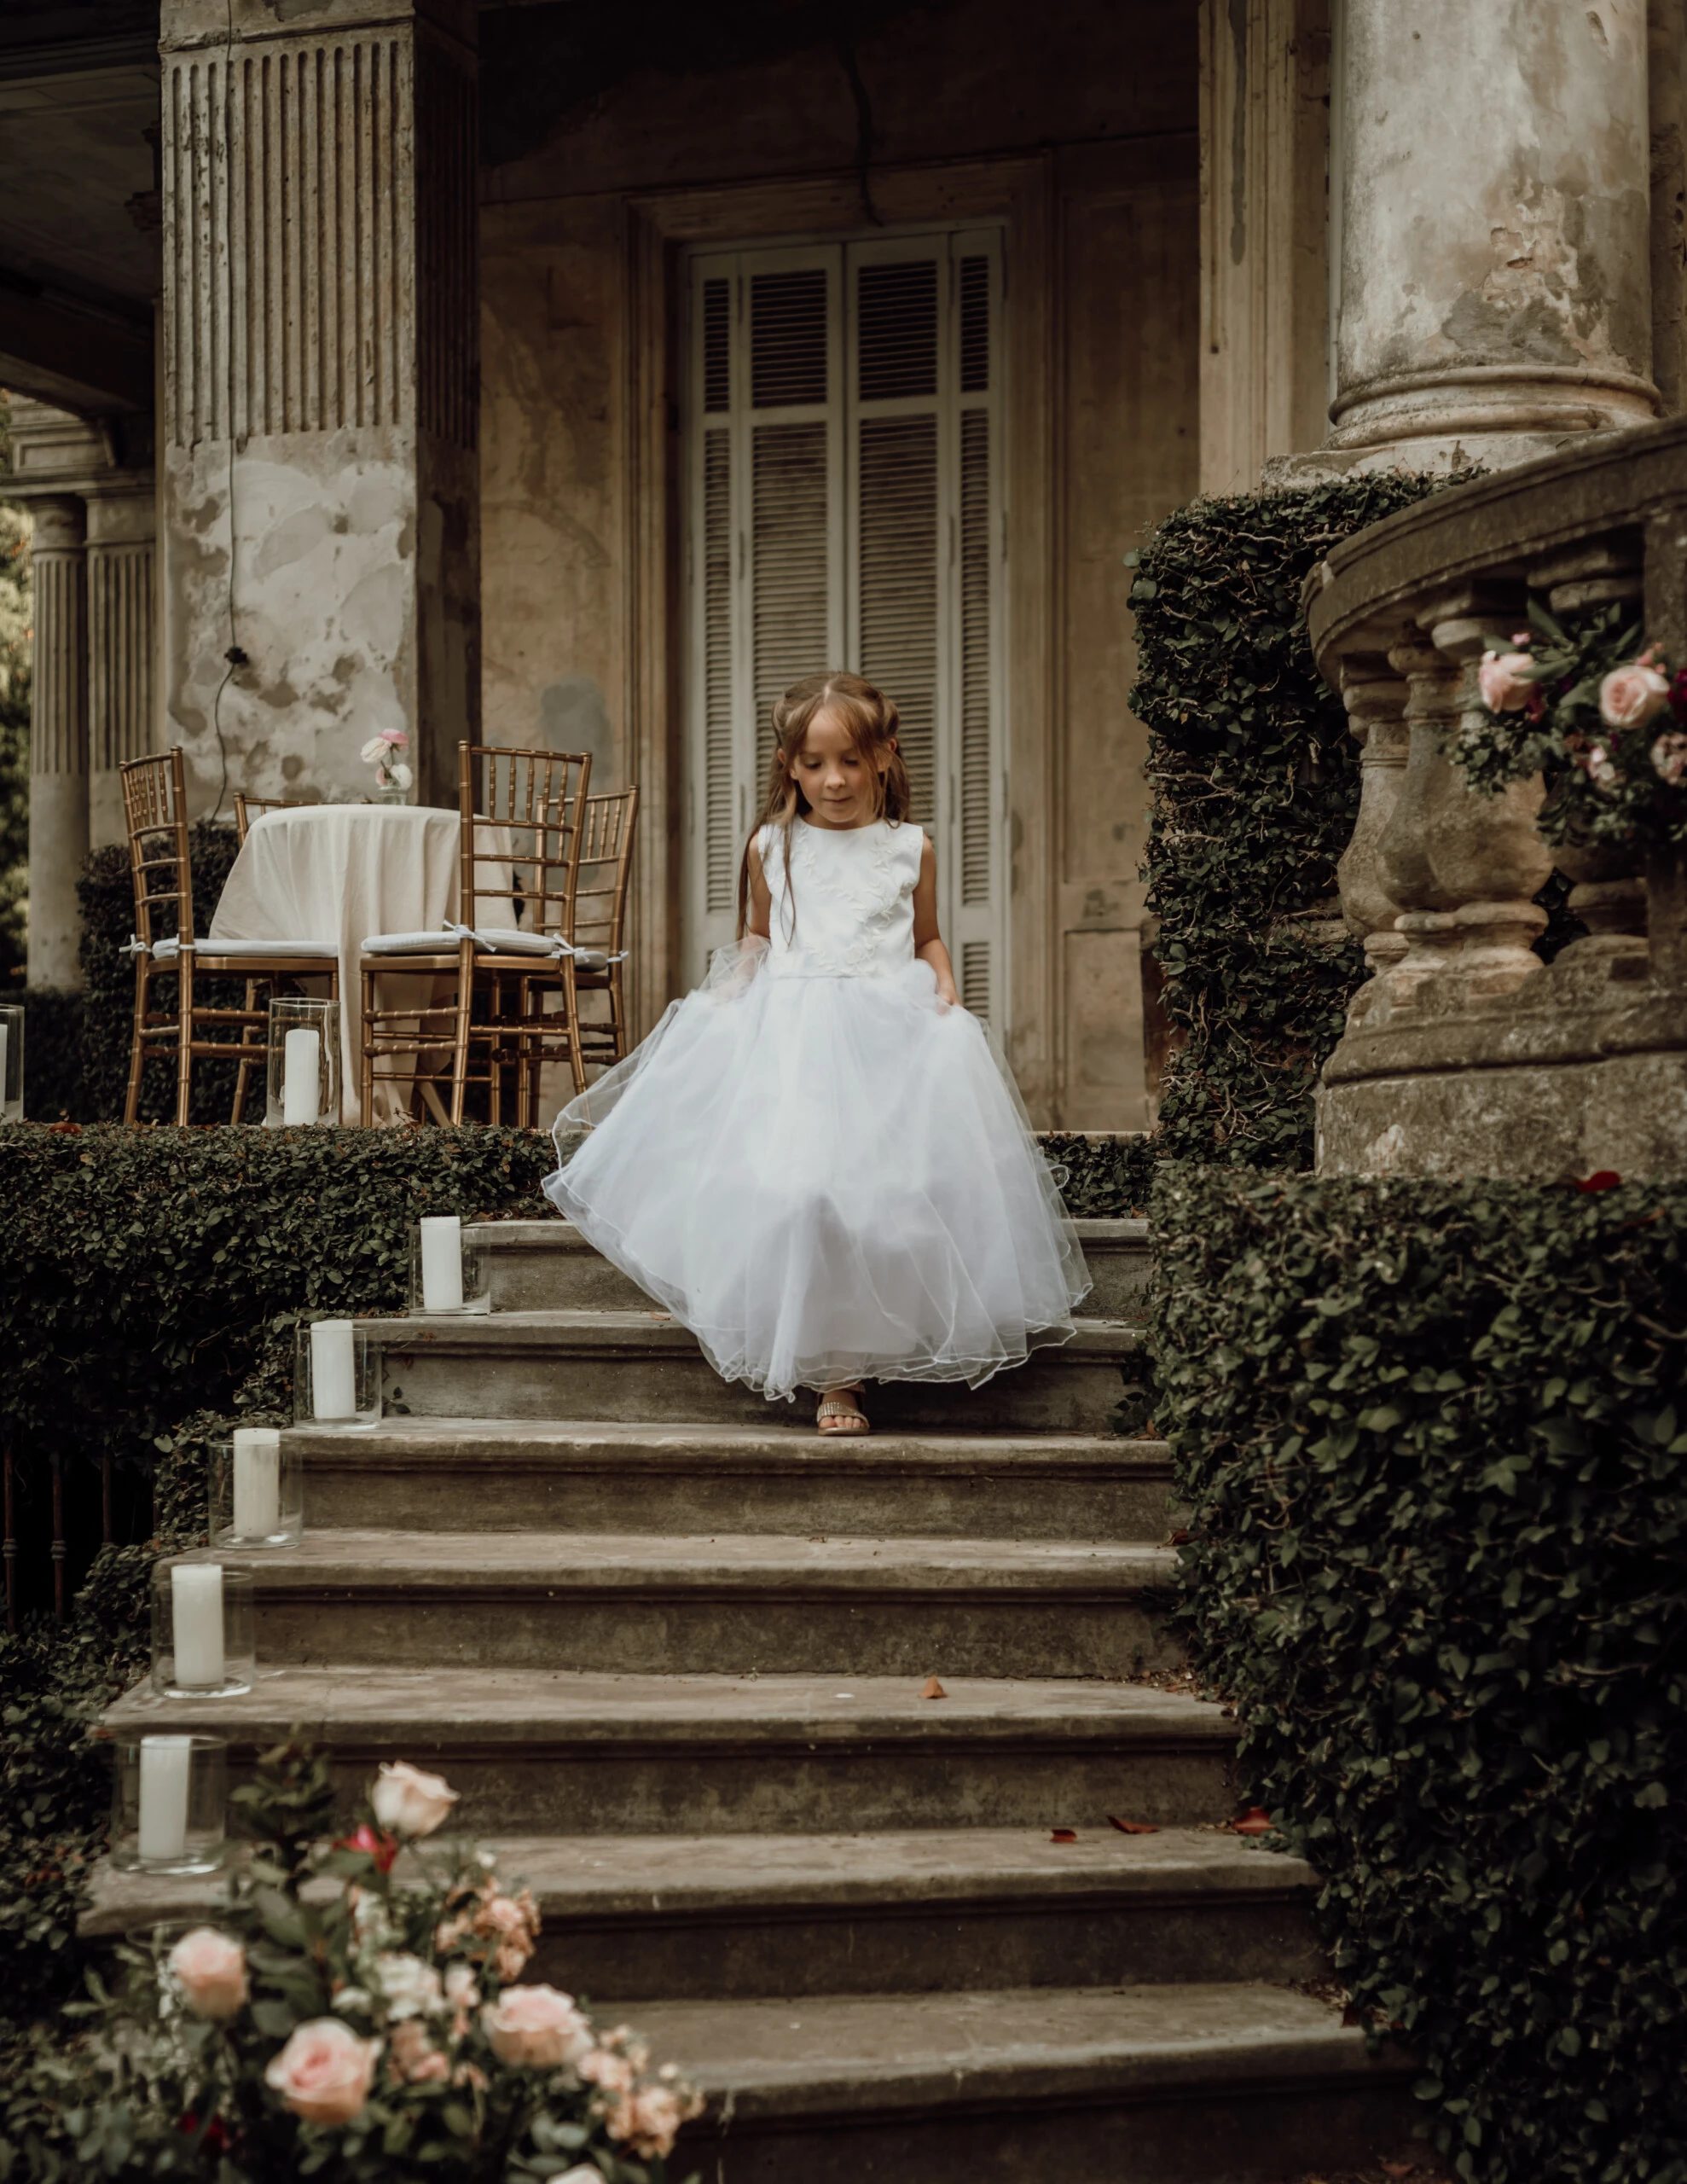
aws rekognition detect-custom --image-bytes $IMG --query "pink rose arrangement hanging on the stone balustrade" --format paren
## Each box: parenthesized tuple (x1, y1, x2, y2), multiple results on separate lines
(1453, 601, 1687, 850)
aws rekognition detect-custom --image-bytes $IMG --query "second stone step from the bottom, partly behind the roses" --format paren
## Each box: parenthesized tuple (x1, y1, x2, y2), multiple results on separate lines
(81, 1826, 1327, 2009)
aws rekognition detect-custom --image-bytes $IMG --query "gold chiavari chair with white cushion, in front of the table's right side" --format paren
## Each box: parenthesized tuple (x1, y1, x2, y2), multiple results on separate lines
(360, 742, 591, 1124)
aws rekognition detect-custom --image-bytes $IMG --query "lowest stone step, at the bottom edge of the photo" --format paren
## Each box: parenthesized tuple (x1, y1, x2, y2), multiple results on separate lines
(637, 1981, 1417, 2184)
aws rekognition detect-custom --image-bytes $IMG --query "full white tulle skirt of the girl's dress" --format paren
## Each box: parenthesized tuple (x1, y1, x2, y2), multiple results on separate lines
(546, 941, 1089, 1397)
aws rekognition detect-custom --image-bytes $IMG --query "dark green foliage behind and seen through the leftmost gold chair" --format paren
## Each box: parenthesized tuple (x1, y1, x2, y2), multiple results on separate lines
(75, 819, 245, 1123)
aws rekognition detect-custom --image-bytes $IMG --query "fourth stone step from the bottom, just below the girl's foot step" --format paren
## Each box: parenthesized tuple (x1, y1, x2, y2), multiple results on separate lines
(172, 1531, 1183, 1680)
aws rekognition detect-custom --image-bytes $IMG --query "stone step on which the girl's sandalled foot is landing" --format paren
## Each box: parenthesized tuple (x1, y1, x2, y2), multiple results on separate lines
(290, 1417, 1172, 1544)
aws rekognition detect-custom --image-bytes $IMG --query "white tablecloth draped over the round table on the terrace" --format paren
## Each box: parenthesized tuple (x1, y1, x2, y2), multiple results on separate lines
(210, 804, 515, 1123)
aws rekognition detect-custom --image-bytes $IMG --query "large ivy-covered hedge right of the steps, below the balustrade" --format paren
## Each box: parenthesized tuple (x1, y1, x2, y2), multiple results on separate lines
(1155, 1166, 1687, 2184)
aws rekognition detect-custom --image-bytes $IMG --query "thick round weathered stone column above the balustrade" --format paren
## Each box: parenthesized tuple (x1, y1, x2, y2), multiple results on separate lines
(1326, 0, 1659, 483)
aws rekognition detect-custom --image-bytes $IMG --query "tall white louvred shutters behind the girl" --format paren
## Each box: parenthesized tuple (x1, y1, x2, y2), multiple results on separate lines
(687, 229, 1006, 1025)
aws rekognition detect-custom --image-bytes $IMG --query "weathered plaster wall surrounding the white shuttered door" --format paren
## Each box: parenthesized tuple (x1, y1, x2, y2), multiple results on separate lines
(480, 0, 1200, 1130)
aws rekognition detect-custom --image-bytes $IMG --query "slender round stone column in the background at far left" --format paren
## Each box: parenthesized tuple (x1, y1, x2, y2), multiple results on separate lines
(28, 494, 87, 987)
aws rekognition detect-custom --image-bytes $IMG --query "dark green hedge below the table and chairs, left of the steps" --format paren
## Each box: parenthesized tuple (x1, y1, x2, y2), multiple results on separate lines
(0, 1123, 552, 1519)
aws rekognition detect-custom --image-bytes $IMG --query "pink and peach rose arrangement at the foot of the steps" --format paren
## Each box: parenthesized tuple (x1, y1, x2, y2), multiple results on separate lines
(47, 1743, 700, 2184)
